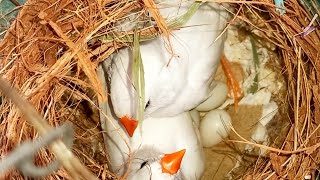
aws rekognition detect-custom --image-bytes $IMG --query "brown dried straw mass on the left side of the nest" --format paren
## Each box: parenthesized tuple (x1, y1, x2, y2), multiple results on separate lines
(0, 0, 149, 179)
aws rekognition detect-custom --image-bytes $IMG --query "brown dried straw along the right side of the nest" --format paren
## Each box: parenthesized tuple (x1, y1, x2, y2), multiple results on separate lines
(224, 0, 320, 179)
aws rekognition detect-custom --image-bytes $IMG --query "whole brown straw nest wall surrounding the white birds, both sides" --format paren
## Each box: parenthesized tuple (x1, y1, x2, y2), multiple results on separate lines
(0, 0, 320, 179)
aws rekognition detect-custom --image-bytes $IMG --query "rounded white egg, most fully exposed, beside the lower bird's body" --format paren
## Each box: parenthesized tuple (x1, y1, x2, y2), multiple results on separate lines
(199, 109, 232, 147)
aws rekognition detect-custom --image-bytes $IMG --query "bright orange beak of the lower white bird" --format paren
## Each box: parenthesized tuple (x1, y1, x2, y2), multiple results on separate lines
(161, 149, 186, 175)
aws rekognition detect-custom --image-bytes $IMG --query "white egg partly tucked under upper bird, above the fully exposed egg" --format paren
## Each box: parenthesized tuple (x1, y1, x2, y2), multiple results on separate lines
(196, 82, 228, 111)
